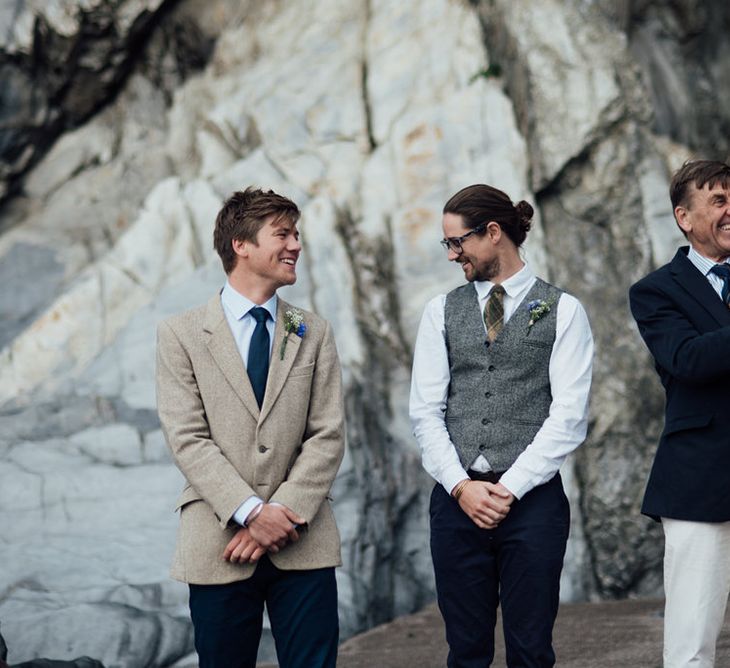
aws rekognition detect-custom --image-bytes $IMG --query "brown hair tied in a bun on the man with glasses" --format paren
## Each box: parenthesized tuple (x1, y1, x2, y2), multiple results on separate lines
(444, 184, 534, 248)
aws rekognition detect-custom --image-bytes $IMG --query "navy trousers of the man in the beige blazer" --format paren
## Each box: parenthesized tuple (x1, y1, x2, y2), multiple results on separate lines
(190, 556, 339, 668)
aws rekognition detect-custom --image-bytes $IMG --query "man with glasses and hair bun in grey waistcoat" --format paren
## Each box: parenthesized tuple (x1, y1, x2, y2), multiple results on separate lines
(410, 185, 593, 668)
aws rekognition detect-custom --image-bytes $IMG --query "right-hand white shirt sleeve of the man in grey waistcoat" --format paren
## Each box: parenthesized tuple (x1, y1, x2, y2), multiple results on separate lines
(500, 293, 593, 498)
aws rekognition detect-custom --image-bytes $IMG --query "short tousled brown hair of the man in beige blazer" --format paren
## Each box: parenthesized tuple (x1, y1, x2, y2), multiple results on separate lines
(213, 186, 301, 274)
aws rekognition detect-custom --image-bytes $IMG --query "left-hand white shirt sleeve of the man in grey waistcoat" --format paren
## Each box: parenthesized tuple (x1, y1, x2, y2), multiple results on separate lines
(409, 295, 469, 493)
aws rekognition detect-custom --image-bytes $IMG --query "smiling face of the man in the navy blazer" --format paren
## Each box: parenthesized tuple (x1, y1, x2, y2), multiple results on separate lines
(674, 184, 730, 262)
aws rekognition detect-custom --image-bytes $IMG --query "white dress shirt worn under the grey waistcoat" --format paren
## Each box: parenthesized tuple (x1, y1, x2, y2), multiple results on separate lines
(410, 265, 593, 499)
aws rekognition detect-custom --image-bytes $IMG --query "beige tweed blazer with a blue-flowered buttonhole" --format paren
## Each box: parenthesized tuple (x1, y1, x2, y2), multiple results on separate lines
(157, 295, 344, 584)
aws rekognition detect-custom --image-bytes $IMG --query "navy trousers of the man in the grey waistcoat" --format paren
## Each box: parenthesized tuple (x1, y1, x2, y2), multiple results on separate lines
(431, 475, 570, 668)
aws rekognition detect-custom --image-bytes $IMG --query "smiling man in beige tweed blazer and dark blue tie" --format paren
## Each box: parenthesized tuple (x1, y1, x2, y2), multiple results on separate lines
(157, 188, 344, 668)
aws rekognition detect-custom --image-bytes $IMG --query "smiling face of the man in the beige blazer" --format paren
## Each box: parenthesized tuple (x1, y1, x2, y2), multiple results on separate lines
(233, 215, 302, 296)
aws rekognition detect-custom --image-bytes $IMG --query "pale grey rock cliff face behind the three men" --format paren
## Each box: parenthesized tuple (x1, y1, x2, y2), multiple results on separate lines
(0, 0, 716, 667)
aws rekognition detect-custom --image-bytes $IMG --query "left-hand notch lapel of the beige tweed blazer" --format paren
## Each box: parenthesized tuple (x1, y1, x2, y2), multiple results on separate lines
(203, 295, 259, 420)
